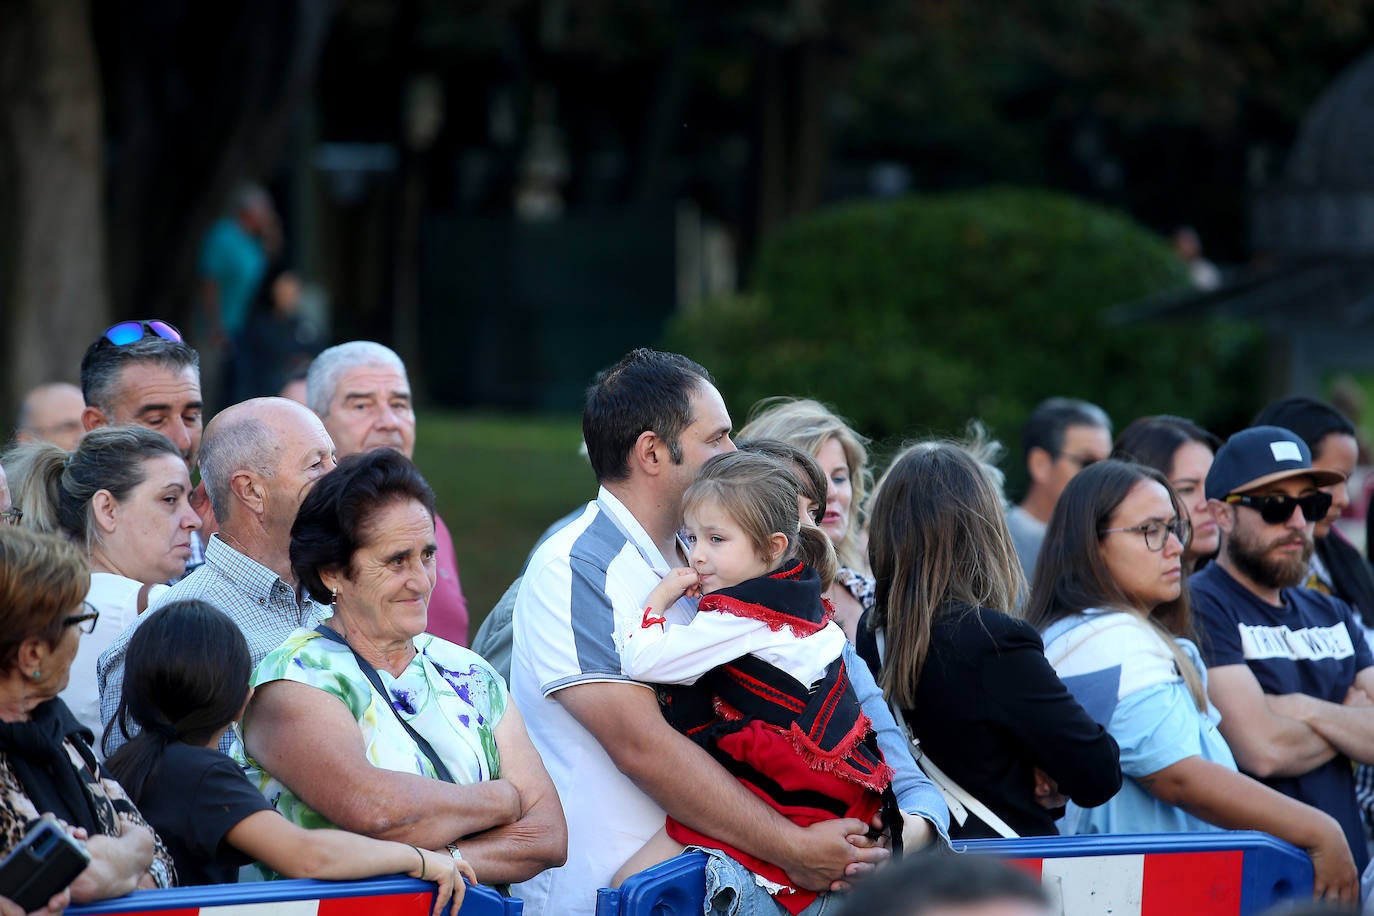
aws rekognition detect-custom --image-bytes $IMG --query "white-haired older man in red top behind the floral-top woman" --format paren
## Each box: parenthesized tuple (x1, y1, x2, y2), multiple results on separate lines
(305, 341, 467, 645)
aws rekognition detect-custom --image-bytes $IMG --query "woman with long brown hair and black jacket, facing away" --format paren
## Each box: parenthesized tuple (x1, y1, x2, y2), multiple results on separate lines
(859, 442, 1121, 839)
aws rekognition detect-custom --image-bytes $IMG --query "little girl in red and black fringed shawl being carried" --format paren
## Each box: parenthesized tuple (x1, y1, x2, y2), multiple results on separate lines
(616, 452, 929, 913)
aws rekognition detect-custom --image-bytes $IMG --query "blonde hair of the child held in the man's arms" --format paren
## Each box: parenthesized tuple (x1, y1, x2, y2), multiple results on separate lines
(683, 452, 840, 589)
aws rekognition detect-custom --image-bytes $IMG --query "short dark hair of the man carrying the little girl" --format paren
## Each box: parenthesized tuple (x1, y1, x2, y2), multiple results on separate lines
(583, 347, 713, 482)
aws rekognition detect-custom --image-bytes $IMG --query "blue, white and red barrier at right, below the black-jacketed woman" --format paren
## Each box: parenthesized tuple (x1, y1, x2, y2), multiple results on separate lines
(596, 831, 1312, 916)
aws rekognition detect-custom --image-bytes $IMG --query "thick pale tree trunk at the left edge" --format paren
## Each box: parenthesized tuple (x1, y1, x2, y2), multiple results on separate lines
(0, 0, 110, 422)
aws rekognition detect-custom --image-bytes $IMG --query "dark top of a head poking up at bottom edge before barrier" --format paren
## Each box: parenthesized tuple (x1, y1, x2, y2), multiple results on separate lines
(838, 849, 1050, 916)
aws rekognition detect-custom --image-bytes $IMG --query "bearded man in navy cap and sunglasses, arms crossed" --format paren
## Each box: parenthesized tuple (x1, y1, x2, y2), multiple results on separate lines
(1189, 426, 1374, 871)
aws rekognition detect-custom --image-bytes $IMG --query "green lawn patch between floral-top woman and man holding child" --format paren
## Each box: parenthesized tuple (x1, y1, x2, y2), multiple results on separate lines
(415, 411, 596, 642)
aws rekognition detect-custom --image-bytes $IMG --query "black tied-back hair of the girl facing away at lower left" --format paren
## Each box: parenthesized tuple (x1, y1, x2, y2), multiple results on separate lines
(104, 599, 253, 805)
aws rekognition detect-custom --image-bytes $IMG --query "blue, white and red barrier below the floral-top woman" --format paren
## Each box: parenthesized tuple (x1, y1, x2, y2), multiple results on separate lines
(67, 876, 525, 916)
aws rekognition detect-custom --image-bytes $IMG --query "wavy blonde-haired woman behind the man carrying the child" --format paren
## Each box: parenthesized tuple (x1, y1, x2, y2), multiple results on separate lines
(738, 398, 872, 643)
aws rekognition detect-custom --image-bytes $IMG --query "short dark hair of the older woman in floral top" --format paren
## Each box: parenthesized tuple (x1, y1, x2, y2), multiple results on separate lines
(291, 449, 434, 604)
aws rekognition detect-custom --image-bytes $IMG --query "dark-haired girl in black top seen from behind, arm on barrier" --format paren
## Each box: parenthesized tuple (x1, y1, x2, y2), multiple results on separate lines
(109, 600, 477, 916)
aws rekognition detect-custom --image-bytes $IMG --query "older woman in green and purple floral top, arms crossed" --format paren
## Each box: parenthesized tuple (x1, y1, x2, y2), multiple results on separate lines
(243, 449, 567, 884)
